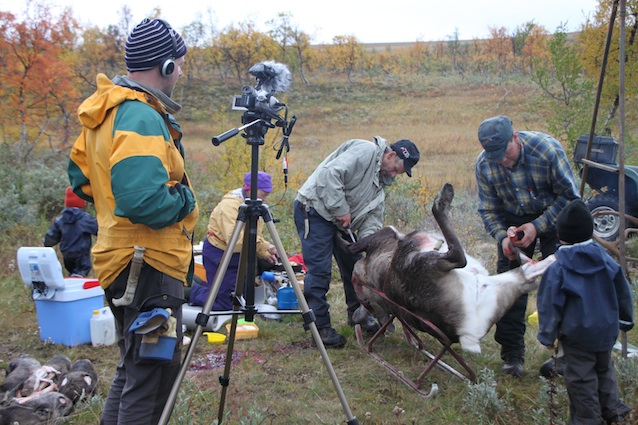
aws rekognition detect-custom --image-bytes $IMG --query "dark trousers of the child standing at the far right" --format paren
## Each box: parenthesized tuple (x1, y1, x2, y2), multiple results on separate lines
(563, 342, 631, 425)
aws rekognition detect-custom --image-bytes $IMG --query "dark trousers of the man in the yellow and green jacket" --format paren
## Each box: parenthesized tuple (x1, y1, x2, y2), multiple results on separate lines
(100, 263, 185, 425)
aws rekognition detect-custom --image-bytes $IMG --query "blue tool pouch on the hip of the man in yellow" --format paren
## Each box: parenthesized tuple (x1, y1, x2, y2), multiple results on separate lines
(129, 307, 177, 360)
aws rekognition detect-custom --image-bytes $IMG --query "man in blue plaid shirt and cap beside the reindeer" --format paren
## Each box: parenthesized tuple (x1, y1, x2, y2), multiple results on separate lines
(476, 116, 579, 377)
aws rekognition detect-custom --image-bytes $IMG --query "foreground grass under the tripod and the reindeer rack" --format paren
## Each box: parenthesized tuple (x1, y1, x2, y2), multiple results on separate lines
(0, 274, 638, 425)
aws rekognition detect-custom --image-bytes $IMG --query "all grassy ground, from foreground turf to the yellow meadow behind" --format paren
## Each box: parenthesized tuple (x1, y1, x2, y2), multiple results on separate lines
(0, 77, 638, 425)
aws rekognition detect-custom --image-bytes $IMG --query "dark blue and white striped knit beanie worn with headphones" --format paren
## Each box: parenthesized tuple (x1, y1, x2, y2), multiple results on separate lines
(124, 18, 186, 71)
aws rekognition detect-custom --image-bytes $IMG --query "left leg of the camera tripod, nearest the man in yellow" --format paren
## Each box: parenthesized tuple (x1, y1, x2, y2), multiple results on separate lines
(159, 220, 245, 425)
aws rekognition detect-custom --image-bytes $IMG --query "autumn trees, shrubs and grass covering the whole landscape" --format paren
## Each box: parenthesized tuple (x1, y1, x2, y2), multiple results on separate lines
(0, 1, 638, 425)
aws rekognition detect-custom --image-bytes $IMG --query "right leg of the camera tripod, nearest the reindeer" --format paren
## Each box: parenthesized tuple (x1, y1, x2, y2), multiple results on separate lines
(266, 220, 359, 424)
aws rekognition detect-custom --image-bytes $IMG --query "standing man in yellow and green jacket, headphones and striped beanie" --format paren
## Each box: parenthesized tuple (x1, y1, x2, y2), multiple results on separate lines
(68, 19, 198, 425)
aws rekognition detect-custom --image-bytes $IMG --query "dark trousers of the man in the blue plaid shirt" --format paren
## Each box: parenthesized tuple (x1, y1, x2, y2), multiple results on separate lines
(494, 210, 559, 360)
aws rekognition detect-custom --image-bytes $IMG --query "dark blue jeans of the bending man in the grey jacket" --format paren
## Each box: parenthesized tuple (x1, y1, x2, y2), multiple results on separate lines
(295, 201, 363, 329)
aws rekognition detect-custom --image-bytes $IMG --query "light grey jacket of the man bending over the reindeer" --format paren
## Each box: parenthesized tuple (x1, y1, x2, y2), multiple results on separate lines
(296, 136, 394, 238)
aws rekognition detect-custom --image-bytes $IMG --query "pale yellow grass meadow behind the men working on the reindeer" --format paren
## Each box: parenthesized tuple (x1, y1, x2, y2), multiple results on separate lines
(183, 78, 547, 195)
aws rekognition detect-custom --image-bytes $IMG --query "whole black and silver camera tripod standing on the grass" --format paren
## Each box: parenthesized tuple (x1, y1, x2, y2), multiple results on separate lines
(159, 116, 359, 425)
